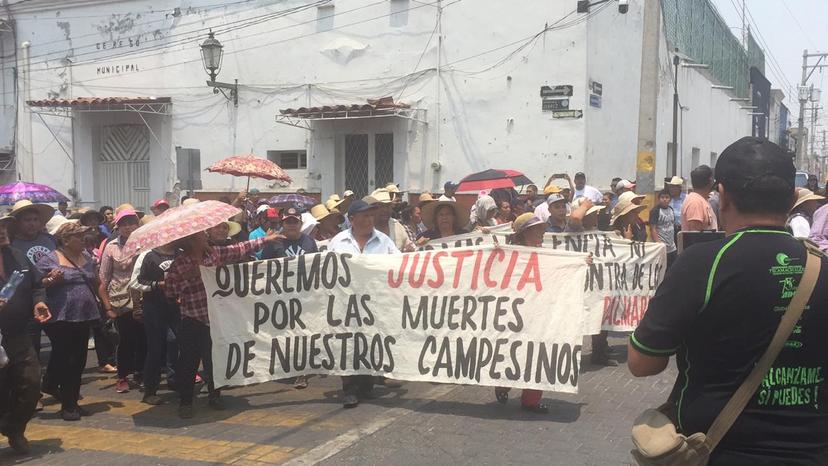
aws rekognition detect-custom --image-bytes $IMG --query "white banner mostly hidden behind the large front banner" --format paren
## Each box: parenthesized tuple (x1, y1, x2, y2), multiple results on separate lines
(421, 231, 667, 335)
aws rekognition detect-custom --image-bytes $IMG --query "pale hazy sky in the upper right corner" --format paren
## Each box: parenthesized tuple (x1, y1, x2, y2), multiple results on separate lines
(711, 0, 828, 124)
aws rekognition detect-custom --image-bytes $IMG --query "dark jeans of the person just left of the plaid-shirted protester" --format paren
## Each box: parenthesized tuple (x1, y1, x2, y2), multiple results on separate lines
(144, 302, 178, 396)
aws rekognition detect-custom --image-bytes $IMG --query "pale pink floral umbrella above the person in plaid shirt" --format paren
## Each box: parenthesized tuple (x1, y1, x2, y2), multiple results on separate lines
(124, 201, 241, 256)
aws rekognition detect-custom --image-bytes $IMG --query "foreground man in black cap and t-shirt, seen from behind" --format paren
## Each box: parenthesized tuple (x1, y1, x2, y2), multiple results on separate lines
(628, 137, 828, 466)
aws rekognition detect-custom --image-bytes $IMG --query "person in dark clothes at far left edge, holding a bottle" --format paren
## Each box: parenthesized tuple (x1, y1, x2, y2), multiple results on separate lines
(0, 216, 51, 454)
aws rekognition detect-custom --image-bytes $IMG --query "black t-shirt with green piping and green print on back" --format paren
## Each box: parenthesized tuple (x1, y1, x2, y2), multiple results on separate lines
(630, 227, 828, 466)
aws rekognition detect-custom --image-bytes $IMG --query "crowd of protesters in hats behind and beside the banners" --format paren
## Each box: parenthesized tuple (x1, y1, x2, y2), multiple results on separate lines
(0, 141, 828, 458)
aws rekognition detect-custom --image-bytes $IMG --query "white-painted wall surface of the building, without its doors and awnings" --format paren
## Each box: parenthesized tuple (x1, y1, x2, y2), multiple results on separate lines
(3, 0, 749, 206)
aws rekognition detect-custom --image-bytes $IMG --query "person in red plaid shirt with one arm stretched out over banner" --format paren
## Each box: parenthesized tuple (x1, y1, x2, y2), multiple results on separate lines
(164, 231, 284, 419)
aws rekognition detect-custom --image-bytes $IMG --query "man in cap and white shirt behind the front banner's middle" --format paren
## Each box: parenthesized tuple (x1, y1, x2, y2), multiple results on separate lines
(328, 200, 400, 408)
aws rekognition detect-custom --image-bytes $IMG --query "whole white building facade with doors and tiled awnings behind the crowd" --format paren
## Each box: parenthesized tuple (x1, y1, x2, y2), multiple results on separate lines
(0, 0, 764, 208)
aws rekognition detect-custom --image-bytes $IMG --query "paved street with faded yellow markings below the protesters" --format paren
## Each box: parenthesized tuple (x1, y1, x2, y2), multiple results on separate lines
(0, 335, 675, 466)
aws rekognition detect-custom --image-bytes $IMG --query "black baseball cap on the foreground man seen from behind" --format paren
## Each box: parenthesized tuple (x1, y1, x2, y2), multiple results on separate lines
(715, 136, 796, 192)
